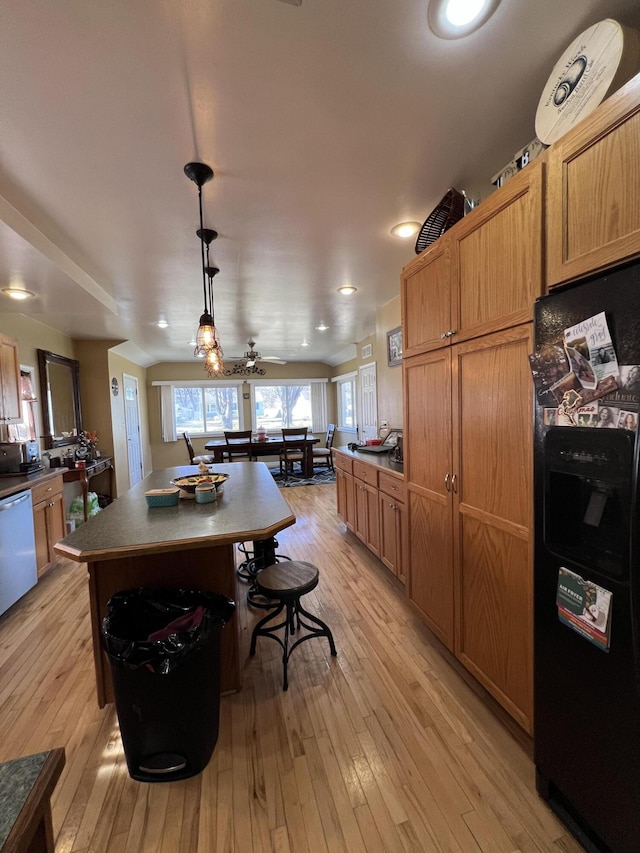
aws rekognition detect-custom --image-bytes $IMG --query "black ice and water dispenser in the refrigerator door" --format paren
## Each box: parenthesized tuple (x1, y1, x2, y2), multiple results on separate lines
(543, 427, 635, 580)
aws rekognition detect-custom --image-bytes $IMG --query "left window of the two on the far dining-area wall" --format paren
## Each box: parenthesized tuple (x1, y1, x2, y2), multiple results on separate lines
(153, 380, 244, 441)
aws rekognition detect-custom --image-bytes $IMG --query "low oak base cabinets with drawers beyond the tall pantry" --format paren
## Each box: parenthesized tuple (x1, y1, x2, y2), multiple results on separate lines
(334, 451, 407, 582)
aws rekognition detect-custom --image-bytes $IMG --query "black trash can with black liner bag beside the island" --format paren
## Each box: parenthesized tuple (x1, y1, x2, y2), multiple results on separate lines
(101, 589, 235, 782)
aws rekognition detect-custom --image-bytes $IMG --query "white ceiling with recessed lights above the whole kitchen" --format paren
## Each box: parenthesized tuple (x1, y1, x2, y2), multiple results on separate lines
(0, 0, 640, 364)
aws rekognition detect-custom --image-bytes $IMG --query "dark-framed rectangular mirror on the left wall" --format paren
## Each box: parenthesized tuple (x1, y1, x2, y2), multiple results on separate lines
(38, 349, 82, 450)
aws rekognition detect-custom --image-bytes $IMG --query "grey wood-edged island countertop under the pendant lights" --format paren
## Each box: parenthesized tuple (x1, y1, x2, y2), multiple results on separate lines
(55, 462, 296, 562)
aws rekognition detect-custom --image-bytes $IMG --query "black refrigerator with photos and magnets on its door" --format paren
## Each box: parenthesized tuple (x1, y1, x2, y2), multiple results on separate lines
(534, 263, 640, 853)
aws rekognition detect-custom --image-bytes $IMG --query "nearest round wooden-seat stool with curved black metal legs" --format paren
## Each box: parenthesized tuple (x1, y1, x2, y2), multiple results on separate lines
(249, 560, 338, 690)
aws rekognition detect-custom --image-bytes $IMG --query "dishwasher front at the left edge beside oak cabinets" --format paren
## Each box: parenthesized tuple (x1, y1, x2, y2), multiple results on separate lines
(0, 489, 38, 614)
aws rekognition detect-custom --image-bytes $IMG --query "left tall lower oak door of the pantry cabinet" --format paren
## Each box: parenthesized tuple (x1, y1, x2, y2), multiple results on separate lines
(403, 348, 453, 649)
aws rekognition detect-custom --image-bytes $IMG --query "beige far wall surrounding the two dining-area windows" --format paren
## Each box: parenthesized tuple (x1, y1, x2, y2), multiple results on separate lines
(147, 360, 335, 469)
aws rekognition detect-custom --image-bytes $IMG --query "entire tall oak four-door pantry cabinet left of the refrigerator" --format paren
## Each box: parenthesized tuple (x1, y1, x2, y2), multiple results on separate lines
(401, 158, 544, 732)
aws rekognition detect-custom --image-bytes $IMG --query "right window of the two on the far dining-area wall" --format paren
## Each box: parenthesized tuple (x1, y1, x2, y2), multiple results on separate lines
(251, 379, 327, 432)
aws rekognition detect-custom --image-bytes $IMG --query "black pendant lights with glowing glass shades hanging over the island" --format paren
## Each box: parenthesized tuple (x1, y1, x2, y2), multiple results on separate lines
(184, 163, 224, 376)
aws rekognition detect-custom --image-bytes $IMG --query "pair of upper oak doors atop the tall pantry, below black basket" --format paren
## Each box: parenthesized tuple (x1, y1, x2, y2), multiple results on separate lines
(401, 158, 545, 357)
